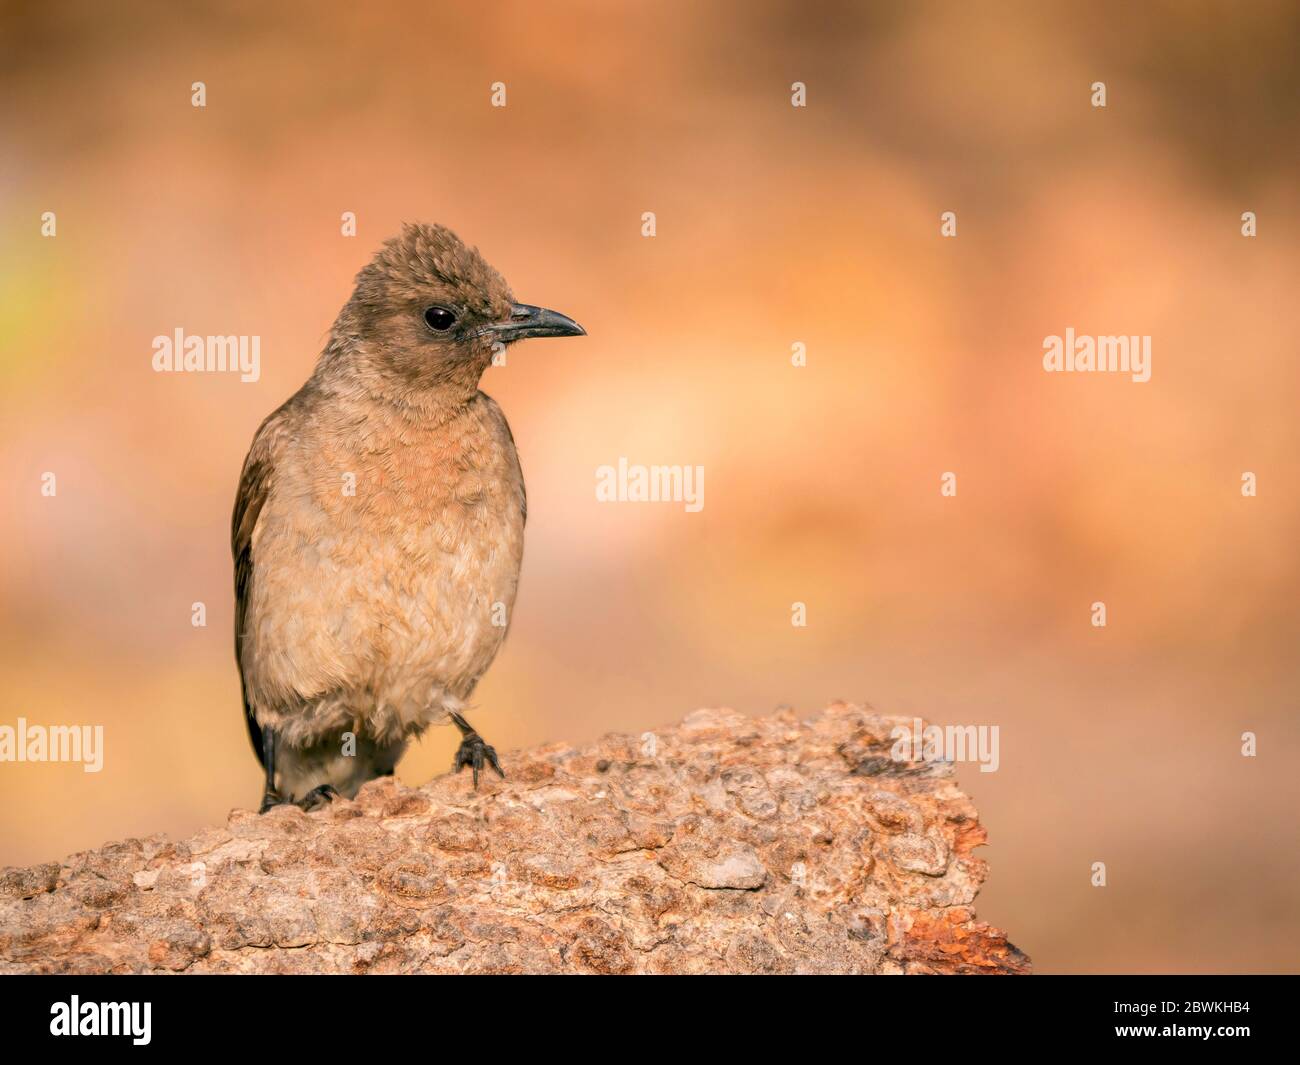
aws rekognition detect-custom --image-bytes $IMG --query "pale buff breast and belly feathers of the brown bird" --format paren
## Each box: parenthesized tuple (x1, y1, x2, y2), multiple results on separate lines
(243, 397, 524, 739)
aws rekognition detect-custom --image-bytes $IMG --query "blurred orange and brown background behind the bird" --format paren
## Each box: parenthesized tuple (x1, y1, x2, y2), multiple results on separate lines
(0, 0, 1300, 973)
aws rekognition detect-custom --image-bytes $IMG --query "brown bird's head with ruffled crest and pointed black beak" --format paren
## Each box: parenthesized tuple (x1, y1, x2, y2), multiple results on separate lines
(335, 224, 586, 388)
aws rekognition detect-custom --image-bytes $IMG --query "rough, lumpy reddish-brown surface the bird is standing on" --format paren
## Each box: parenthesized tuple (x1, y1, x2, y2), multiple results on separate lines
(0, 703, 1030, 973)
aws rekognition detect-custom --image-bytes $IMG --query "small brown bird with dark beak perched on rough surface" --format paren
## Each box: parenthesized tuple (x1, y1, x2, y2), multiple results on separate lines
(230, 222, 586, 813)
